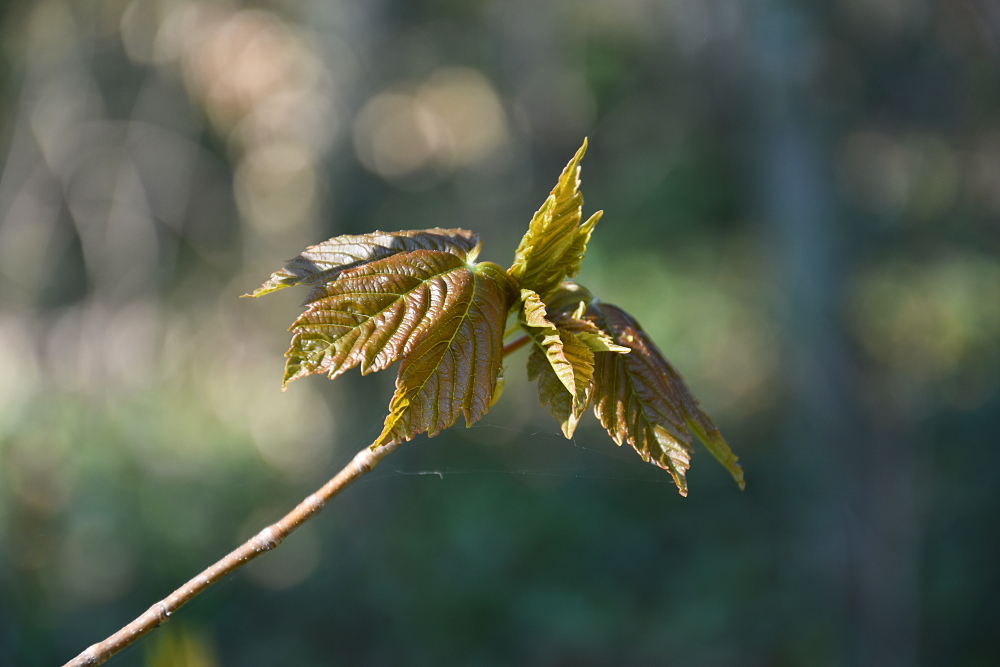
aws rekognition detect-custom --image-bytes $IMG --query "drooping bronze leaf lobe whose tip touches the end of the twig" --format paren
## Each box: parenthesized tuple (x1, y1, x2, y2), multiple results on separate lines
(372, 258, 515, 449)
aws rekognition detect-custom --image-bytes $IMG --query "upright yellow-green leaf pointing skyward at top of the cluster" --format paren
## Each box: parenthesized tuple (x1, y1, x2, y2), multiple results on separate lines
(508, 140, 604, 299)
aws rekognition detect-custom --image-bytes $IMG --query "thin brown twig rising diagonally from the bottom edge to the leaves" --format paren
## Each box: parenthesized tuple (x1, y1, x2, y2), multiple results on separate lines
(64, 443, 399, 667)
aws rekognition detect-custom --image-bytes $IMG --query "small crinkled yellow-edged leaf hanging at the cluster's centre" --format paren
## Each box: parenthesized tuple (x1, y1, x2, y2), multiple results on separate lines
(521, 289, 594, 438)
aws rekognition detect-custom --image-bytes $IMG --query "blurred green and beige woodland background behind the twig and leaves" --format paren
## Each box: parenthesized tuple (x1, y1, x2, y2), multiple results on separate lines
(0, 0, 1000, 667)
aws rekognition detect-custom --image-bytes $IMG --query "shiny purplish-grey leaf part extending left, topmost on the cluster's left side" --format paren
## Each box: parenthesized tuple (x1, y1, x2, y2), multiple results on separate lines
(244, 227, 481, 301)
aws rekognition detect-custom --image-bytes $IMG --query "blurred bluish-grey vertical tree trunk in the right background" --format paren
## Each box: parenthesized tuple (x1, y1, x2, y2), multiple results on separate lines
(753, 7, 920, 667)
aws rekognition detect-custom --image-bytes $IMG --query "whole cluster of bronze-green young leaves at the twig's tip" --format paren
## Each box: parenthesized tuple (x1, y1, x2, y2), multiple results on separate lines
(247, 141, 744, 495)
